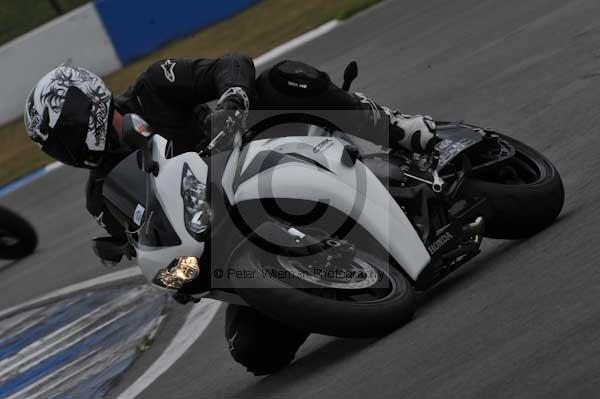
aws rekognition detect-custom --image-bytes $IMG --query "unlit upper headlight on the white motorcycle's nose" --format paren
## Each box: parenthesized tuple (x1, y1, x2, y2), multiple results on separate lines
(181, 164, 213, 241)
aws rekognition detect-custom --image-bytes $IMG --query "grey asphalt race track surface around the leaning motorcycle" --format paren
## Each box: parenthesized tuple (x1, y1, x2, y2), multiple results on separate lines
(0, 0, 600, 399)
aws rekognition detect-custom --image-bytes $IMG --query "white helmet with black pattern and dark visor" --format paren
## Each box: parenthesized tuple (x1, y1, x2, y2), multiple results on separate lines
(25, 66, 112, 168)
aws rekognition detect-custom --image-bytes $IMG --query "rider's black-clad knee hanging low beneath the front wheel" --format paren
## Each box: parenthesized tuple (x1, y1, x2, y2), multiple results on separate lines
(225, 305, 309, 375)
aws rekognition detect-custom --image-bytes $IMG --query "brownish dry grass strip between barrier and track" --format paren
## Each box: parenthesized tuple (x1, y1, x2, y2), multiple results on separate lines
(0, 0, 376, 185)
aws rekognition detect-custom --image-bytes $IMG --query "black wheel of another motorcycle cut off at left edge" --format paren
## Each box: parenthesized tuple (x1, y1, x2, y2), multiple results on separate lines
(0, 207, 38, 259)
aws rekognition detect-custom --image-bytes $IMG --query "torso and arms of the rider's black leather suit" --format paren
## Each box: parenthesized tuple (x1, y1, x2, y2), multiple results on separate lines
(86, 54, 255, 238)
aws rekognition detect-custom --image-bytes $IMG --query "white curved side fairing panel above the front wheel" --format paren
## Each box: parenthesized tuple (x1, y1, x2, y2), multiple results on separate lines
(222, 137, 431, 279)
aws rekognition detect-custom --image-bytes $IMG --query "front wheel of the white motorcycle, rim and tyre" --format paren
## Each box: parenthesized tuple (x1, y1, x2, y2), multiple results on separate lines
(231, 248, 415, 337)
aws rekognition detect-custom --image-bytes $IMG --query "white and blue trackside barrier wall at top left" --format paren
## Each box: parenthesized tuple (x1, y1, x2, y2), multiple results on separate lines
(0, 0, 258, 124)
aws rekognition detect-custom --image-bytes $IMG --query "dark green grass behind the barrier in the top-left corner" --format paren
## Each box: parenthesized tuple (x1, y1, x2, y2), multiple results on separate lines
(0, 0, 89, 45)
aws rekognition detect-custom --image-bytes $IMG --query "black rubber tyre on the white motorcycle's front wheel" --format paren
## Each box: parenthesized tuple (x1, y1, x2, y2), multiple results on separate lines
(231, 248, 415, 337)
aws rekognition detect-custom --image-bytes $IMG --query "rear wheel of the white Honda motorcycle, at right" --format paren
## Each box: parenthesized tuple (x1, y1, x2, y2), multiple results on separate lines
(462, 135, 564, 239)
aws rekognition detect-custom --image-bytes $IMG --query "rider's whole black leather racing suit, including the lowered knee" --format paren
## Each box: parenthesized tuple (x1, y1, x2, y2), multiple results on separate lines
(87, 54, 412, 374)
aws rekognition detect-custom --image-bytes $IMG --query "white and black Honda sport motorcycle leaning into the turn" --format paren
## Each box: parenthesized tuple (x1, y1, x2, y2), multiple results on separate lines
(95, 64, 564, 337)
